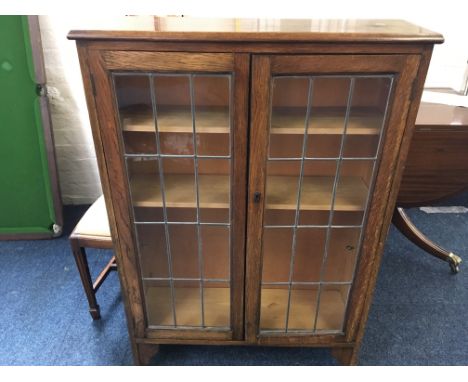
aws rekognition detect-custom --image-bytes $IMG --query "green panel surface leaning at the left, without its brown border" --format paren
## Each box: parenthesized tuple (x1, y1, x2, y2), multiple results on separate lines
(0, 16, 55, 234)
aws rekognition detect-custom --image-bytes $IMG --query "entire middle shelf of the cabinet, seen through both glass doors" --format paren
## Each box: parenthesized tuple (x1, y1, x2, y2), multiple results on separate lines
(131, 174, 367, 211)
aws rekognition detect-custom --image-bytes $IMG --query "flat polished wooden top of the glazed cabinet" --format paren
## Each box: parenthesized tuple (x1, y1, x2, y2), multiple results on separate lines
(68, 16, 443, 43)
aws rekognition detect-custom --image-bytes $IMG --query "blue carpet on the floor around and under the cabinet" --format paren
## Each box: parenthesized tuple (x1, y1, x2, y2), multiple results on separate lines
(0, 195, 468, 365)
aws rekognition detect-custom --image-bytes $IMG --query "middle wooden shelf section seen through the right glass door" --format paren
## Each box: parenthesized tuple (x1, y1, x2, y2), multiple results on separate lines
(266, 176, 367, 211)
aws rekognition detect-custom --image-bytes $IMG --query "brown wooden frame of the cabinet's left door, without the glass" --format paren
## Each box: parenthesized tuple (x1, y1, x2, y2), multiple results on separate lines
(86, 49, 250, 344)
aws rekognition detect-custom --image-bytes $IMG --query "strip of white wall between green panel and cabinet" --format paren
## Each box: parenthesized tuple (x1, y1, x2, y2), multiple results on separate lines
(39, 16, 101, 204)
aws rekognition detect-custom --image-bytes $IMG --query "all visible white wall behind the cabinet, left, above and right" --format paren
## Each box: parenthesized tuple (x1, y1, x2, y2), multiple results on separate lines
(40, 0, 468, 204)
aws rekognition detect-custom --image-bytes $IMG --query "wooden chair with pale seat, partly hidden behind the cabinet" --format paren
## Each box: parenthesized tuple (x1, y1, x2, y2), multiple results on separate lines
(69, 196, 117, 320)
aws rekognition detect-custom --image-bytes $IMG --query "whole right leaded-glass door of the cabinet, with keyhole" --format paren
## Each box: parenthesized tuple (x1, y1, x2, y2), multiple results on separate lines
(246, 55, 419, 344)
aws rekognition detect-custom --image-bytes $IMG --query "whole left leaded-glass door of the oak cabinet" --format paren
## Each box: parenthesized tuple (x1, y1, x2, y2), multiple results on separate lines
(90, 51, 249, 339)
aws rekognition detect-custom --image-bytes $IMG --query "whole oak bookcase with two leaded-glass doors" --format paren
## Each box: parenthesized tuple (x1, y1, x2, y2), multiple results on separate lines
(69, 17, 443, 364)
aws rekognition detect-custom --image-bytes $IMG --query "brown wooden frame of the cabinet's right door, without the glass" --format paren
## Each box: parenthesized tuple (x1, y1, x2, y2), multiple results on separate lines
(245, 54, 421, 345)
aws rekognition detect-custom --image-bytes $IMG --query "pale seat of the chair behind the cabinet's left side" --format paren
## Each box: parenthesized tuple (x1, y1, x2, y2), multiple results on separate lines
(73, 195, 111, 238)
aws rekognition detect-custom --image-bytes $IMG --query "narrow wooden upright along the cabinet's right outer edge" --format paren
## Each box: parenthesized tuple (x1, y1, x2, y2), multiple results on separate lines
(346, 47, 432, 352)
